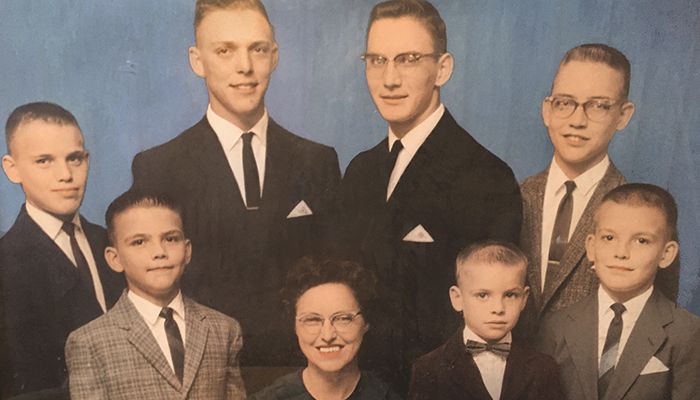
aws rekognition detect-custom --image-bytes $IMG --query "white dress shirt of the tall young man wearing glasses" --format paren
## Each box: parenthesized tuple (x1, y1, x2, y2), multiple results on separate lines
(386, 103, 445, 201)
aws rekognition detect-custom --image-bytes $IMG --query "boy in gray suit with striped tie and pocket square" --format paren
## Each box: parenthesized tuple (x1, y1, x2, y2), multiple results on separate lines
(540, 184, 700, 400)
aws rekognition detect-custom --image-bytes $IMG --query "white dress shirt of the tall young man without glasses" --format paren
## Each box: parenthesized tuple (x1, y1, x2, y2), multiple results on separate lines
(207, 104, 269, 204)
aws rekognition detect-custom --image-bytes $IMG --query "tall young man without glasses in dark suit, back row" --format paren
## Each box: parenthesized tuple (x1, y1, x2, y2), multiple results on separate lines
(132, 0, 340, 382)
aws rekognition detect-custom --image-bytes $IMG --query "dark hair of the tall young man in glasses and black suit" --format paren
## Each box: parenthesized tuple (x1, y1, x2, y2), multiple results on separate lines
(367, 0, 447, 53)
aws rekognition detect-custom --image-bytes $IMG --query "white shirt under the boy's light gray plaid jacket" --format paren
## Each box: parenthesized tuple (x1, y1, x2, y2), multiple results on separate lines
(127, 290, 187, 372)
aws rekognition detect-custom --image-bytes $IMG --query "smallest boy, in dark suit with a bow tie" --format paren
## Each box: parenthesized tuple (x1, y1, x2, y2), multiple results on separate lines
(409, 241, 562, 400)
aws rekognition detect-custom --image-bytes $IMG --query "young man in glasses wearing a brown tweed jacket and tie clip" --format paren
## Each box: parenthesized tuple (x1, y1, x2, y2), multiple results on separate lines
(516, 44, 679, 340)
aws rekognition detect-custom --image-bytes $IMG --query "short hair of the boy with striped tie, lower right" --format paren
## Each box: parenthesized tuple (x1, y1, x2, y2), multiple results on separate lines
(595, 183, 678, 240)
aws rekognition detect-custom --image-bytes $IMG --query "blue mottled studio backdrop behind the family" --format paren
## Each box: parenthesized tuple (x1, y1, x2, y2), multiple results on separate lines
(0, 0, 700, 314)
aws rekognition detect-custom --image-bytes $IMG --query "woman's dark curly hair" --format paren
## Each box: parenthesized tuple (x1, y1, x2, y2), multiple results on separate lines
(282, 256, 377, 321)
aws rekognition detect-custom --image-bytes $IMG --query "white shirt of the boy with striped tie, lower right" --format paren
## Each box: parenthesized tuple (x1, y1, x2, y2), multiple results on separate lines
(598, 285, 654, 365)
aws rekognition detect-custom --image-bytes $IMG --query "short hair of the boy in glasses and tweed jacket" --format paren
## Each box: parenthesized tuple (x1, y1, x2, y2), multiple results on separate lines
(559, 43, 632, 99)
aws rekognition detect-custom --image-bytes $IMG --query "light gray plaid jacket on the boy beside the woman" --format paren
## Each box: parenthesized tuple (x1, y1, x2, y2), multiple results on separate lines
(66, 291, 245, 400)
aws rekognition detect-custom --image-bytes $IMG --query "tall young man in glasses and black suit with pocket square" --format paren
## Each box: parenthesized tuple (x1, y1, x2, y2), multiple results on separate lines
(339, 0, 521, 392)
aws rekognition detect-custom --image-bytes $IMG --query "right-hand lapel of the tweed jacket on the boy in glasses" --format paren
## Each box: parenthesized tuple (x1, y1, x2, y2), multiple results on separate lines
(540, 161, 622, 310)
